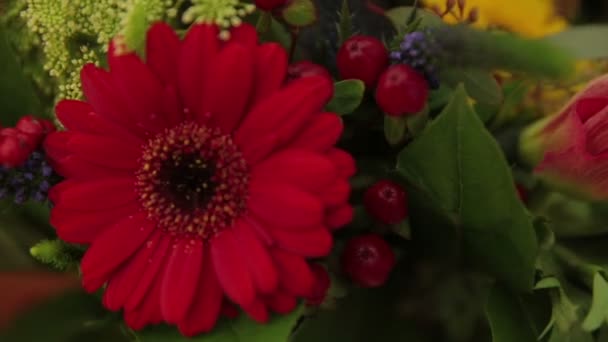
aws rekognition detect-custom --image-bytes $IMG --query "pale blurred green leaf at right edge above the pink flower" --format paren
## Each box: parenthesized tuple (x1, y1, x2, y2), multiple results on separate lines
(546, 25, 608, 59)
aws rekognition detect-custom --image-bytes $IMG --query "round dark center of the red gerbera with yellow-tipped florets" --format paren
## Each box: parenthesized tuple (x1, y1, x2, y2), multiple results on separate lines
(136, 122, 249, 239)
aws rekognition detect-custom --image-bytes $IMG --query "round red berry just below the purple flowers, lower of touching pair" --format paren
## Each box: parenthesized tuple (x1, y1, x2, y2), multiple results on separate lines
(376, 64, 429, 116)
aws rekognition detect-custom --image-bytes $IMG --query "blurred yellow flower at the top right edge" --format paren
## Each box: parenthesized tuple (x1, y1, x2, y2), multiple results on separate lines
(423, 0, 567, 38)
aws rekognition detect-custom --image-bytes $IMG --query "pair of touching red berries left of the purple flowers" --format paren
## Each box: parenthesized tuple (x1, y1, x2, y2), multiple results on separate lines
(338, 35, 429, 116)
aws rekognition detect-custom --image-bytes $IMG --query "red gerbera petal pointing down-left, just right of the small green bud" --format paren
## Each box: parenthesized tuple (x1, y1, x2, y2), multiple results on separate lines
(81, 213, 155, 292)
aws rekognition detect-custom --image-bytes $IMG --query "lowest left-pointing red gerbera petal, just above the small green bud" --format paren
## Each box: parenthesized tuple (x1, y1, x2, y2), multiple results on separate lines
(50, 202, 139, 244)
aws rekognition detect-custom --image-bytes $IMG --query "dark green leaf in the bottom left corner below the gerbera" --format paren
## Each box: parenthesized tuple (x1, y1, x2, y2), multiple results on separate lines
(0, 292, 126, 342)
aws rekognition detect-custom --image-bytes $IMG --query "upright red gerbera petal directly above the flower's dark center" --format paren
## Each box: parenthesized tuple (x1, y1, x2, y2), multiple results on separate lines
(177, 24, 220, 114)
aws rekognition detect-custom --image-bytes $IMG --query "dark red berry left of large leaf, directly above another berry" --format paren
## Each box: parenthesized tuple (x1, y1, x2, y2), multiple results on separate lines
(363, 180, 408, 224)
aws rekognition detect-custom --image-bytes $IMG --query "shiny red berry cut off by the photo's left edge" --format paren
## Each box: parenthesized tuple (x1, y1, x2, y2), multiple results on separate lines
(0, 128, 37, 167)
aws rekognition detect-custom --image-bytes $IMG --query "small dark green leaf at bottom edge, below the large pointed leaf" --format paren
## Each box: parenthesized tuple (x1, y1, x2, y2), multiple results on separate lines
(486, 286, 550, 342)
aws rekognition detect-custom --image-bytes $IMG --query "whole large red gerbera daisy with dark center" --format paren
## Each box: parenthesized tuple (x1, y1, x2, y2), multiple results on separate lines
(46, 24, 355, 335)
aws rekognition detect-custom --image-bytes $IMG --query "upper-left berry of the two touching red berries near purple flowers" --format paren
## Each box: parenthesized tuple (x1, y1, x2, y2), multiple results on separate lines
(337, 35, 389, 89)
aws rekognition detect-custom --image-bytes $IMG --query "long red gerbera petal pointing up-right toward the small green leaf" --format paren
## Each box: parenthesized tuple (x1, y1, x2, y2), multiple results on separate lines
(235, 77, 333, 150)
